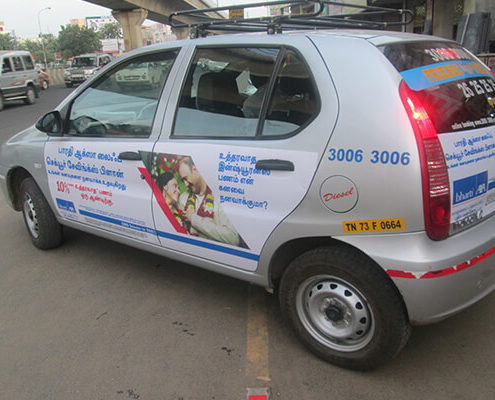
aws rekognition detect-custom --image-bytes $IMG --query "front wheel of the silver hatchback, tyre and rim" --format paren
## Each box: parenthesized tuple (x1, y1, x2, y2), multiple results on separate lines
(20, 178, 62, 250)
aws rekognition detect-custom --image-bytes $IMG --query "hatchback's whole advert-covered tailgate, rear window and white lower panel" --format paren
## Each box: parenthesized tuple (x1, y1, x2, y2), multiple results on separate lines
(383, 42, 495, 233)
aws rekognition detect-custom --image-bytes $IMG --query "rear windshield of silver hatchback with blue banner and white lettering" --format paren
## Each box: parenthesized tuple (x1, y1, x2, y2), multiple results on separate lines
(380, 41, 495, 133)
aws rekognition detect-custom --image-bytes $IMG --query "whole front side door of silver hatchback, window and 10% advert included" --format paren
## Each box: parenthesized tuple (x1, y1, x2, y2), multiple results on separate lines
(45, 49, 178, 243)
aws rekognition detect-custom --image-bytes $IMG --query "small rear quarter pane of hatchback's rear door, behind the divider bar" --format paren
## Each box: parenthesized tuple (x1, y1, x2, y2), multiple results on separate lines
(263, 50, 318, 136)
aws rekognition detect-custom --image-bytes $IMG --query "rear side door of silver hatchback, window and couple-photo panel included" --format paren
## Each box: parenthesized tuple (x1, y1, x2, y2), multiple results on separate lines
(146, 36, 337, 271)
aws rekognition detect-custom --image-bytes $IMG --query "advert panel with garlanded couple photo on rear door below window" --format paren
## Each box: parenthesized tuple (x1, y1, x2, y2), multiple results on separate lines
(140, 143, 317, 271)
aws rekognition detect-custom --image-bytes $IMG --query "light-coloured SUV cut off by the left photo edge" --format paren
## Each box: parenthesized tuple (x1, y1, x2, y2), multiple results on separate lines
(0, 50, 40, 110)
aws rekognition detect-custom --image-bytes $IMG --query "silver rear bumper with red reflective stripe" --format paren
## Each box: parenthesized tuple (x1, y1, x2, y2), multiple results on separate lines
(341, 217, 495, 324)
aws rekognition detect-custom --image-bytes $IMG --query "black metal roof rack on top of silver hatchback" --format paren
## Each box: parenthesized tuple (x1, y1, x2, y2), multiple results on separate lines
(169, 0, 414, 38)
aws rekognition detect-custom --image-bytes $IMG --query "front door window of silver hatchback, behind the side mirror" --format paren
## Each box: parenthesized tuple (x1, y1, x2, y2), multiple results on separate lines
(68, 50, 178, 137)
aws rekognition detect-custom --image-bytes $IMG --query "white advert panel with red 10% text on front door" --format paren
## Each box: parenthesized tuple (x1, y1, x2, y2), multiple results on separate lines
(45, 138, 158, 247)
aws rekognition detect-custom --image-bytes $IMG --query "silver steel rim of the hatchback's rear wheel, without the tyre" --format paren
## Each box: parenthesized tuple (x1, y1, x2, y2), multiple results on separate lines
(296, 275, 375, 352)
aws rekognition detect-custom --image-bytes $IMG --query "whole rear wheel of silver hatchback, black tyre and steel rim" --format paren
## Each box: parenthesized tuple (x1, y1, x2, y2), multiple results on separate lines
(279, 245, 411, 370)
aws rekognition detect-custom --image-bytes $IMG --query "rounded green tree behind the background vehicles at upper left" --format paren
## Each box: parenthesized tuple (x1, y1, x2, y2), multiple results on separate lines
(58, 25, 101, 59)
